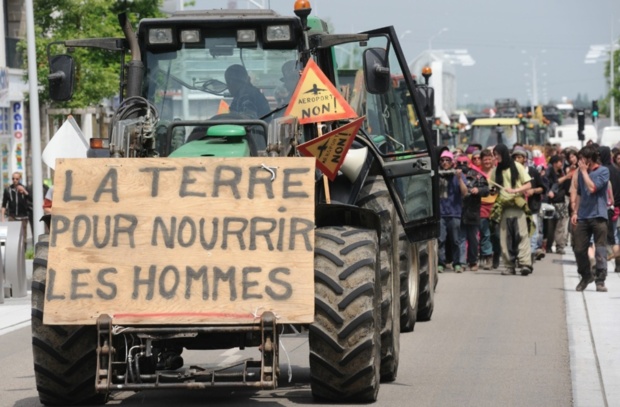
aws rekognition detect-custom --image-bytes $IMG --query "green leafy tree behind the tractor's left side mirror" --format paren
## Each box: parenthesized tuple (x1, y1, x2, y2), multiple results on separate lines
(19, 0, 163, 108)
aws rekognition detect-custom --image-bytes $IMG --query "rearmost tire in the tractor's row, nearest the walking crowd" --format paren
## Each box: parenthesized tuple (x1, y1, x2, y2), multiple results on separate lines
(414, 240, 438, 321)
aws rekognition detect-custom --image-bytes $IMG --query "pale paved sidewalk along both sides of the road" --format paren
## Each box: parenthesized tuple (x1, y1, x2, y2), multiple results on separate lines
(0, 255, 620, 407)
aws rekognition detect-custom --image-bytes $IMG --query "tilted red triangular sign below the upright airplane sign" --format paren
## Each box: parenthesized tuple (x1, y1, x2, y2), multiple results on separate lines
(297, 116, 365, 181)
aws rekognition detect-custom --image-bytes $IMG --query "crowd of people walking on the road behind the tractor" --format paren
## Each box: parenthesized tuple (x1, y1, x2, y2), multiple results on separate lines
(438, 143, 620, 292)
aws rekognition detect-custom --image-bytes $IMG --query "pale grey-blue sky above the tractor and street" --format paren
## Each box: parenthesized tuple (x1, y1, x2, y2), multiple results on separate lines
(179, 0, 620, 109)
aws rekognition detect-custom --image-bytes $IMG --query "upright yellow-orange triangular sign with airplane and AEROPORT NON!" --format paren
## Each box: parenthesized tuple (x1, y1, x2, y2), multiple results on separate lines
(285, 59, 357, 124)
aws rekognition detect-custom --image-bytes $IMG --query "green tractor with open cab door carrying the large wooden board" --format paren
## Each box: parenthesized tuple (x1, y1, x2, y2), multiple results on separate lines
(32, 2, 439, 405)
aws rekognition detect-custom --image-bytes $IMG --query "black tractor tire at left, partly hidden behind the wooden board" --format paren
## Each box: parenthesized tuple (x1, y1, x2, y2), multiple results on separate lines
(32, 235, 108, 406)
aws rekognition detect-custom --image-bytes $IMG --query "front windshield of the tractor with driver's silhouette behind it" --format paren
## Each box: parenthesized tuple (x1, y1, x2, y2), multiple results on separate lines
(144, 30, 299, 120)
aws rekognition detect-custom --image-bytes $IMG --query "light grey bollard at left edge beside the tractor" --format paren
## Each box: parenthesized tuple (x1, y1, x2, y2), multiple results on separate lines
(0, 222, 28, 297)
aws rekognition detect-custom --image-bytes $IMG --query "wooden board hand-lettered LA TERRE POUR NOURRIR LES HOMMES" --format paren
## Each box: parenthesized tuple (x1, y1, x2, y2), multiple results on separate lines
(44, 157, 315, 325)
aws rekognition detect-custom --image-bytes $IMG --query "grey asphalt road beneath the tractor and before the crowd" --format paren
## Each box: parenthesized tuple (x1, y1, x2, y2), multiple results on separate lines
(0, 254, 572, 407)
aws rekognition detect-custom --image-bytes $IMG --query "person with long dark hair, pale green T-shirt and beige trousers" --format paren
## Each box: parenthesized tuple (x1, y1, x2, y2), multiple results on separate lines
(490, 143, 533, 276)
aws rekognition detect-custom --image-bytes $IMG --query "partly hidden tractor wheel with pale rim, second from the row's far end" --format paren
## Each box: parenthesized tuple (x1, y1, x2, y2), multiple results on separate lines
(398, 223, 420, 332)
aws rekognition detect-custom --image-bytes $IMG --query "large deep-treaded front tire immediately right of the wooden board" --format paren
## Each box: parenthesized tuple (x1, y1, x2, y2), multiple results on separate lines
(308, 226, 381, 402)
